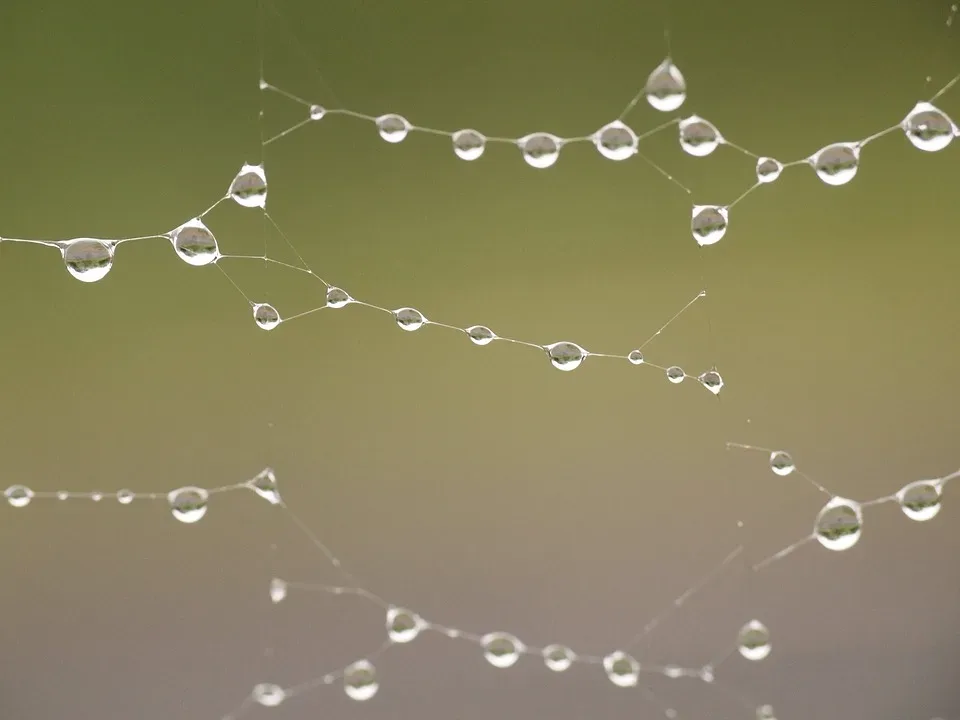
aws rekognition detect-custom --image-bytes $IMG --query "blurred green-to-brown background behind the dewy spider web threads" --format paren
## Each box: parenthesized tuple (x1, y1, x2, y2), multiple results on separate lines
(0, 0, 960, 720)
